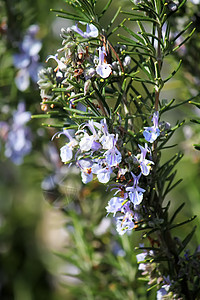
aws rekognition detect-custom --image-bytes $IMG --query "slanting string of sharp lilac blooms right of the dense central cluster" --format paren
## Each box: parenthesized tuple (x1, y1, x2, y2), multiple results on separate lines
(106, 112, 160, 235)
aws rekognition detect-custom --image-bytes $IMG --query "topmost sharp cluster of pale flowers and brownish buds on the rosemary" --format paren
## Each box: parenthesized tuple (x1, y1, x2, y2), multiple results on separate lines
(43, 22, 131, 88)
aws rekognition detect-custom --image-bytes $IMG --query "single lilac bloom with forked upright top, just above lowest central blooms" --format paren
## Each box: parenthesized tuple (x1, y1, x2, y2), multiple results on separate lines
(126, 172, 145, 207)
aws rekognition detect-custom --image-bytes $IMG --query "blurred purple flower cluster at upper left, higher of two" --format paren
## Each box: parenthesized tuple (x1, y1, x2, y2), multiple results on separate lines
(13, 25, 42, 91)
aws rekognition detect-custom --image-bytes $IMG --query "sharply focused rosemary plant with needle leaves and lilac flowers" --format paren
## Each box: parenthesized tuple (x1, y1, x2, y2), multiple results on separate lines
(36, 0, 200, 300)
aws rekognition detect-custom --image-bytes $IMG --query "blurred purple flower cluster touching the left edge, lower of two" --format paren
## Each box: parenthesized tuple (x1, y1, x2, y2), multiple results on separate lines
(0, 102, 32, 165)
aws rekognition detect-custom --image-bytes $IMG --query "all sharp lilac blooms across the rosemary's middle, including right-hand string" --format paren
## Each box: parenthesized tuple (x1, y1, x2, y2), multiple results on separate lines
(56, 112, 160, 234)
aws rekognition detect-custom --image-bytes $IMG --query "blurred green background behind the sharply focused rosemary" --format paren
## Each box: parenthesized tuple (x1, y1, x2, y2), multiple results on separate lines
(0, 0, 200, 300)
